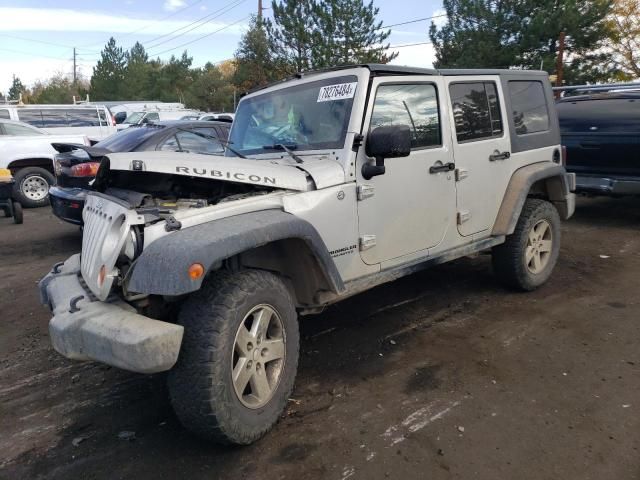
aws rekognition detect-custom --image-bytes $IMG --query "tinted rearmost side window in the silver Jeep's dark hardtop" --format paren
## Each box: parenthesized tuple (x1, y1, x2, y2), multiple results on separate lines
(509, 80, 549, 135)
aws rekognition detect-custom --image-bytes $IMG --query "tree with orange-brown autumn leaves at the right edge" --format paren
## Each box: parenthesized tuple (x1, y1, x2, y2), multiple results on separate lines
(609, 0, 640, 80)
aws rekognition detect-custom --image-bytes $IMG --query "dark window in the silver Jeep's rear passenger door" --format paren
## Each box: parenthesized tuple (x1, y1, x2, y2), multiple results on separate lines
(449, 82, 502, 142)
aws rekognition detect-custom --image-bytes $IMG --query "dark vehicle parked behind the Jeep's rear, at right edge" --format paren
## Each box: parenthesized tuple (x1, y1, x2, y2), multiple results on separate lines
(556, 92, 640, 195)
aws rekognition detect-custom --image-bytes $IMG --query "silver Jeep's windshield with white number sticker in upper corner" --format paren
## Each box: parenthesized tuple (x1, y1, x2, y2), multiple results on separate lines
(228, 75, 358, 155)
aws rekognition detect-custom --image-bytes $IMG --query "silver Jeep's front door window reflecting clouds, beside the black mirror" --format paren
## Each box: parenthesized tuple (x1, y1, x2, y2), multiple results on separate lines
(369, 83, 442, 149)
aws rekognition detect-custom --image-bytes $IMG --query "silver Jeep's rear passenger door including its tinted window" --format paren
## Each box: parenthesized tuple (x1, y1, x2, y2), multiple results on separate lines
(445, 75, 512, 236)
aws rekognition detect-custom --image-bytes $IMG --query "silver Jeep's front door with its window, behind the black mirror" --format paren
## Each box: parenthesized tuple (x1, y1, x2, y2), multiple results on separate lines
(356, 76, 455, 265)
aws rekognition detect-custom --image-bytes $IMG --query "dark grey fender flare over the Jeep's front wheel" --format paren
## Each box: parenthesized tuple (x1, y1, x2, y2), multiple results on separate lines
(127, 210, 345, 296)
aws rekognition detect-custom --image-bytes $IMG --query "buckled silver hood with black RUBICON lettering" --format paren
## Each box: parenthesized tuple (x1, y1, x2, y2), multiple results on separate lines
(107, 152, 344, 192)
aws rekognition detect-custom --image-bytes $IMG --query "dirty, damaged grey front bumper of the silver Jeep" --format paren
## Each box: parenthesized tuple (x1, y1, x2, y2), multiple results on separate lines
(39, 254, 184, 373)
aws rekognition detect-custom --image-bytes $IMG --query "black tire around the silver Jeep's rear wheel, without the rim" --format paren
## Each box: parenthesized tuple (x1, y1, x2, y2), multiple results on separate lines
(492, 198, 560, 291)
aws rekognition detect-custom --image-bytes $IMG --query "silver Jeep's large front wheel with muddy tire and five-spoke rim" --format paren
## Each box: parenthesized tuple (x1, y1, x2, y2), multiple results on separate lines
(169, 270, 299, 445)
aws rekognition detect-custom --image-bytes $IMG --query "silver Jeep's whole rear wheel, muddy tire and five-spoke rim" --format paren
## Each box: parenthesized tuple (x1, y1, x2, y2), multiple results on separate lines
(492, 198, 560, 291)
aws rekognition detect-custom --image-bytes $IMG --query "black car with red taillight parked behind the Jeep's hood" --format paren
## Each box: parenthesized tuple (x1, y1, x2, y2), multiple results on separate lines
(49, 121, 231, 225)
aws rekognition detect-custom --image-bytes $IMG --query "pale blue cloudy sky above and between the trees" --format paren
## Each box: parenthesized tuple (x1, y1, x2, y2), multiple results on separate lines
(0, 0, 445, 93)
